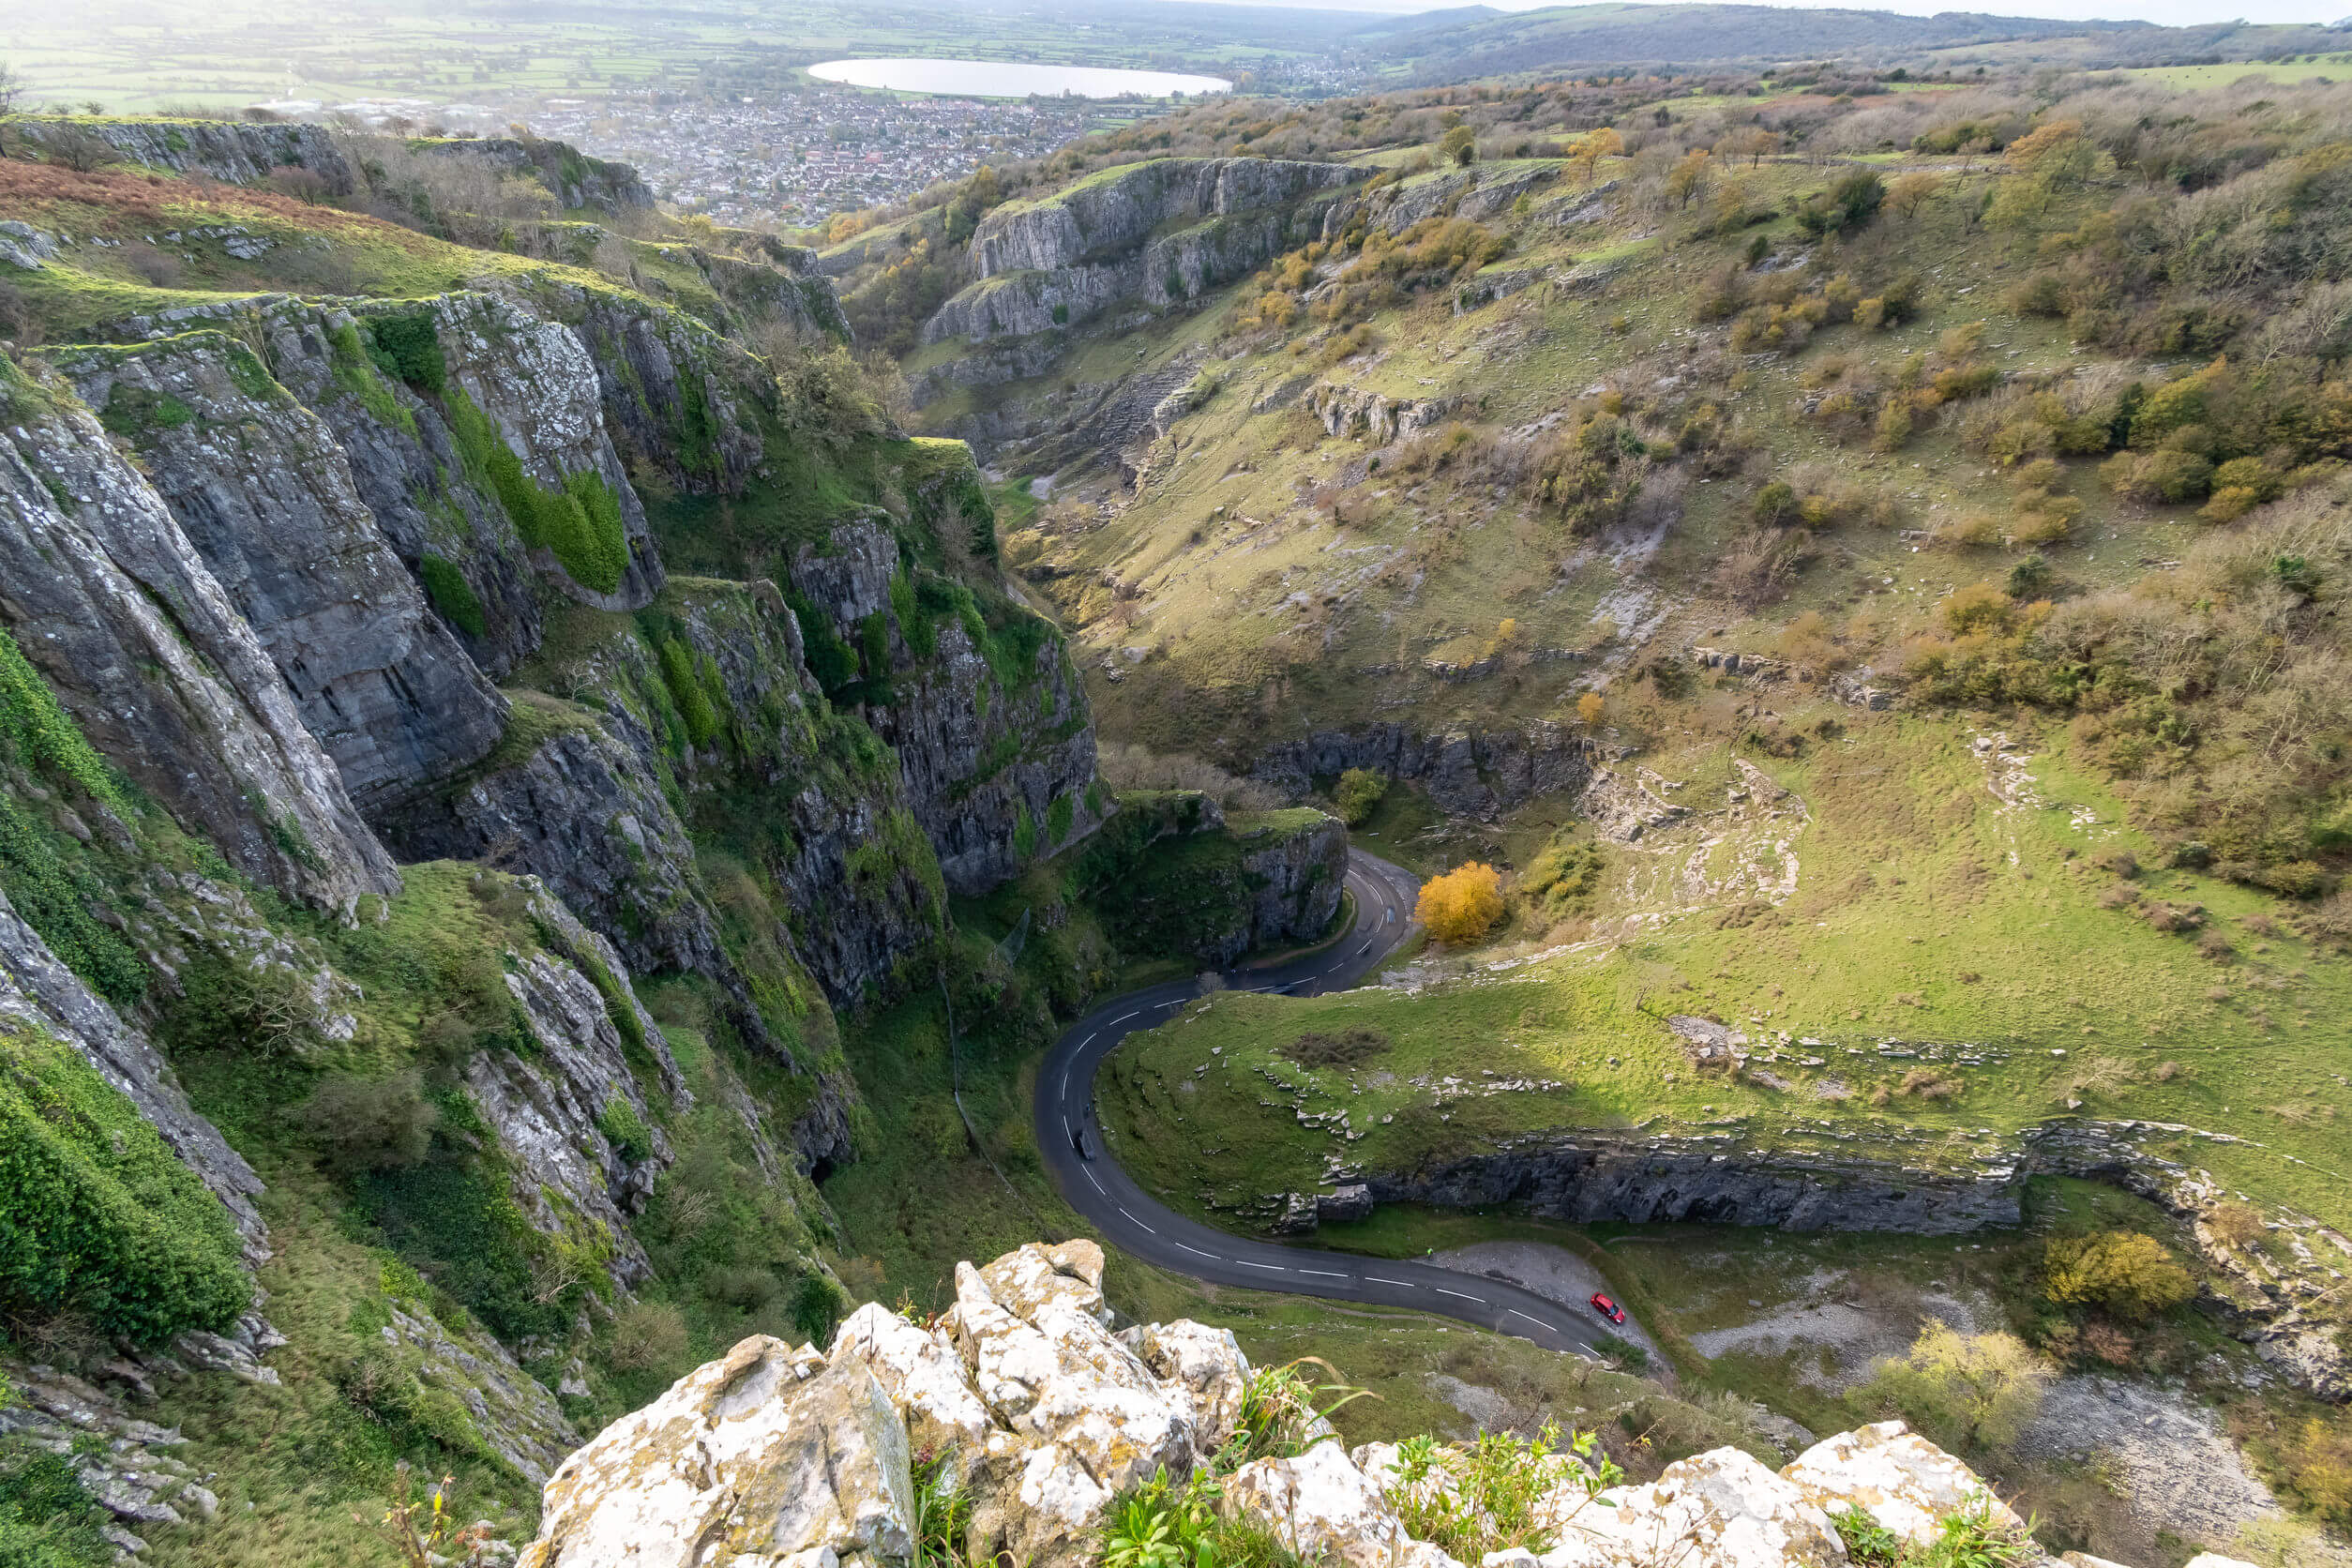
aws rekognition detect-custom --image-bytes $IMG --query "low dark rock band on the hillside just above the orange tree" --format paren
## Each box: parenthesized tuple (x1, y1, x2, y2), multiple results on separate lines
(1251, 719, 1597, 821)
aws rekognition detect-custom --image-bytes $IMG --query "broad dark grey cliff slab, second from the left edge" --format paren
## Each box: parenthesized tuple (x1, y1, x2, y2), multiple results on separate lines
(59, 331, 505, 811)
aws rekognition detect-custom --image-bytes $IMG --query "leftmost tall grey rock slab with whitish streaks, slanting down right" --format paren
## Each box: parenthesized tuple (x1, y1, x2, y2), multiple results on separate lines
(0, 385, 400, 910)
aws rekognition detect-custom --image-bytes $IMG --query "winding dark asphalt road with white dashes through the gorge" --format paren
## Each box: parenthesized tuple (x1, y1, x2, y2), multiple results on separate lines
(1037, 849, 1602, 1354)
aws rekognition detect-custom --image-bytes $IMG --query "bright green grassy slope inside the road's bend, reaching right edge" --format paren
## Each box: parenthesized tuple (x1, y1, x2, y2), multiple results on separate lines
(1106, 717, 2352, 1225)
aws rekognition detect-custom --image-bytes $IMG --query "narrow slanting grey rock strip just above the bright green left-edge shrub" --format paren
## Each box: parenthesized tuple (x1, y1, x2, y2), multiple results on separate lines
(0, 894, 268, 1262)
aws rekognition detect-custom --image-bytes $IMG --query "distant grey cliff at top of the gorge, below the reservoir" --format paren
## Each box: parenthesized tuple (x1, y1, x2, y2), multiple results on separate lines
(922, 158, 1360, 354)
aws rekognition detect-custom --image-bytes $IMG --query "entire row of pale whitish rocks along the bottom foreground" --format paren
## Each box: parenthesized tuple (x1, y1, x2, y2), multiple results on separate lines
(522, 1242, 2227, 1568)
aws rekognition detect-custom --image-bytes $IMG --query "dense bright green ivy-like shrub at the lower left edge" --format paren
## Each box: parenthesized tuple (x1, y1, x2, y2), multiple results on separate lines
(0, 1025, 251, 1345)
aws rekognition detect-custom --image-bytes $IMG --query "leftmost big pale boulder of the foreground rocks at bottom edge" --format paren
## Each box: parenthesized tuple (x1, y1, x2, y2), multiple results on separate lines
(520, 1335, 915, 1568)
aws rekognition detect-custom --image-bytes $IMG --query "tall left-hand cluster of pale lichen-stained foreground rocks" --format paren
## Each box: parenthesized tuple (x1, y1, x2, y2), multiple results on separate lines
(522, 1242, 1249, 1568)
